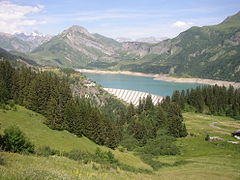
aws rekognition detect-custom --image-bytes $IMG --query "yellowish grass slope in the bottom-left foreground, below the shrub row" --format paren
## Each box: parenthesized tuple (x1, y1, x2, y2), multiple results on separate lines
(0, 153, 158, 180)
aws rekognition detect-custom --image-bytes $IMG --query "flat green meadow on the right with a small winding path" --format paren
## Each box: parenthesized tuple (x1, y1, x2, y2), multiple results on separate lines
(157, 113, 240, 180)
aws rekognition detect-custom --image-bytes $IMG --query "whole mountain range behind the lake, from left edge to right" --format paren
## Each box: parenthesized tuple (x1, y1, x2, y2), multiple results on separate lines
(0, 13, 240, 82)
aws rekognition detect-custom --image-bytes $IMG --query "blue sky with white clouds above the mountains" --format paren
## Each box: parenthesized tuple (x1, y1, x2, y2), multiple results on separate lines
(0, 0, 240, 39)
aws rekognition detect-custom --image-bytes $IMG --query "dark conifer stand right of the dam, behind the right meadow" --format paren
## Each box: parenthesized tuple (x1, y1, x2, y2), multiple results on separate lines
(170, 85, 240, 119)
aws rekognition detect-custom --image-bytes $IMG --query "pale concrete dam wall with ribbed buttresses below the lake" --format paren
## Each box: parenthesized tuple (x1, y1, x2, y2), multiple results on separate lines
(103, 88, 163, 106)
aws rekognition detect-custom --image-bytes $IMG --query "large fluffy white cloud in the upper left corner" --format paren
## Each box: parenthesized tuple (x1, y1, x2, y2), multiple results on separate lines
(0, 1, 45, 33)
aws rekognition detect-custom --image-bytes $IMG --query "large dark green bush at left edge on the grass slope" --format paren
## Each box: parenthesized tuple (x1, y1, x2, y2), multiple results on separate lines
(1, 126, 34, 153)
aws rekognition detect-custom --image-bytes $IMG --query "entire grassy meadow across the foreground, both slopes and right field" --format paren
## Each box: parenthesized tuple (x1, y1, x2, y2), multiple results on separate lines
(0, 106, 240, 180)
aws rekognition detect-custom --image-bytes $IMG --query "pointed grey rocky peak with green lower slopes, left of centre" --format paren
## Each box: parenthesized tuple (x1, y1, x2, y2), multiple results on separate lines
(31, 26, 124, 67)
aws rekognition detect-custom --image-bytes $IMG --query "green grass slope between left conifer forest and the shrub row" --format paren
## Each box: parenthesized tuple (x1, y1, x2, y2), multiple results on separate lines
(0, 106, 151, 169)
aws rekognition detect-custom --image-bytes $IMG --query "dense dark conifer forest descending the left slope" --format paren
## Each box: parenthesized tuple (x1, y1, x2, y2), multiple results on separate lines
(0, 61, 119, 148)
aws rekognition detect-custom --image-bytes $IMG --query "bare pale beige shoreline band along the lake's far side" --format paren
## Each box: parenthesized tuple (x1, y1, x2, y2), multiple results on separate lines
(76, 69, 240, 88)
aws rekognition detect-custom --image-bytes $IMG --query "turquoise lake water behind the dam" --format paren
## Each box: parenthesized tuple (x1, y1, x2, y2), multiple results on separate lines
(83, 73, 204, 96)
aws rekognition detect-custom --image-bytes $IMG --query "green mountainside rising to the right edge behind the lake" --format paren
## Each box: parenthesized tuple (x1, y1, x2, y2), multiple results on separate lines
(119, 13, 240, 82)
